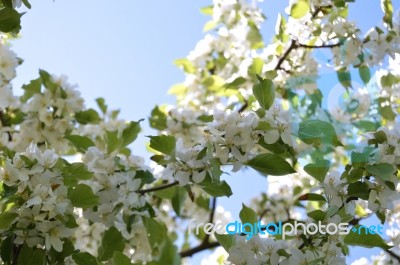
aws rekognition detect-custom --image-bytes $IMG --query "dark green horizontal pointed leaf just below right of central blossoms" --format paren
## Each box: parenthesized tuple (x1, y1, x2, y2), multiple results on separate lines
(247, 154, 296, 176)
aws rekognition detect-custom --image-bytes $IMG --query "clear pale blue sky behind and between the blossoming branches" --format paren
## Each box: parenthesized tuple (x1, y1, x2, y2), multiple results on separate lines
(8, 0, 400, 264)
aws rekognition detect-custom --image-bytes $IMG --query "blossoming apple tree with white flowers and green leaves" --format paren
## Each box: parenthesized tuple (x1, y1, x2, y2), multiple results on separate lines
(0, 0, 400, 265)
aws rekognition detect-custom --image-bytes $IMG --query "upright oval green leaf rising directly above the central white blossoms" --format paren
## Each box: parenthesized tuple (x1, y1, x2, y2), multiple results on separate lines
(253, 75, 275, 109)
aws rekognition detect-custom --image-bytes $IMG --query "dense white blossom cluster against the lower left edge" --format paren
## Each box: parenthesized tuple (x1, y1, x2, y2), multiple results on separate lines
(0, 144, 74, 252)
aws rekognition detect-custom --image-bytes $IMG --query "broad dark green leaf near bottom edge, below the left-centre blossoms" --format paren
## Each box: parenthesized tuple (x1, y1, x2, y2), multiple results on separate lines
(98, 226, 125, 261)
